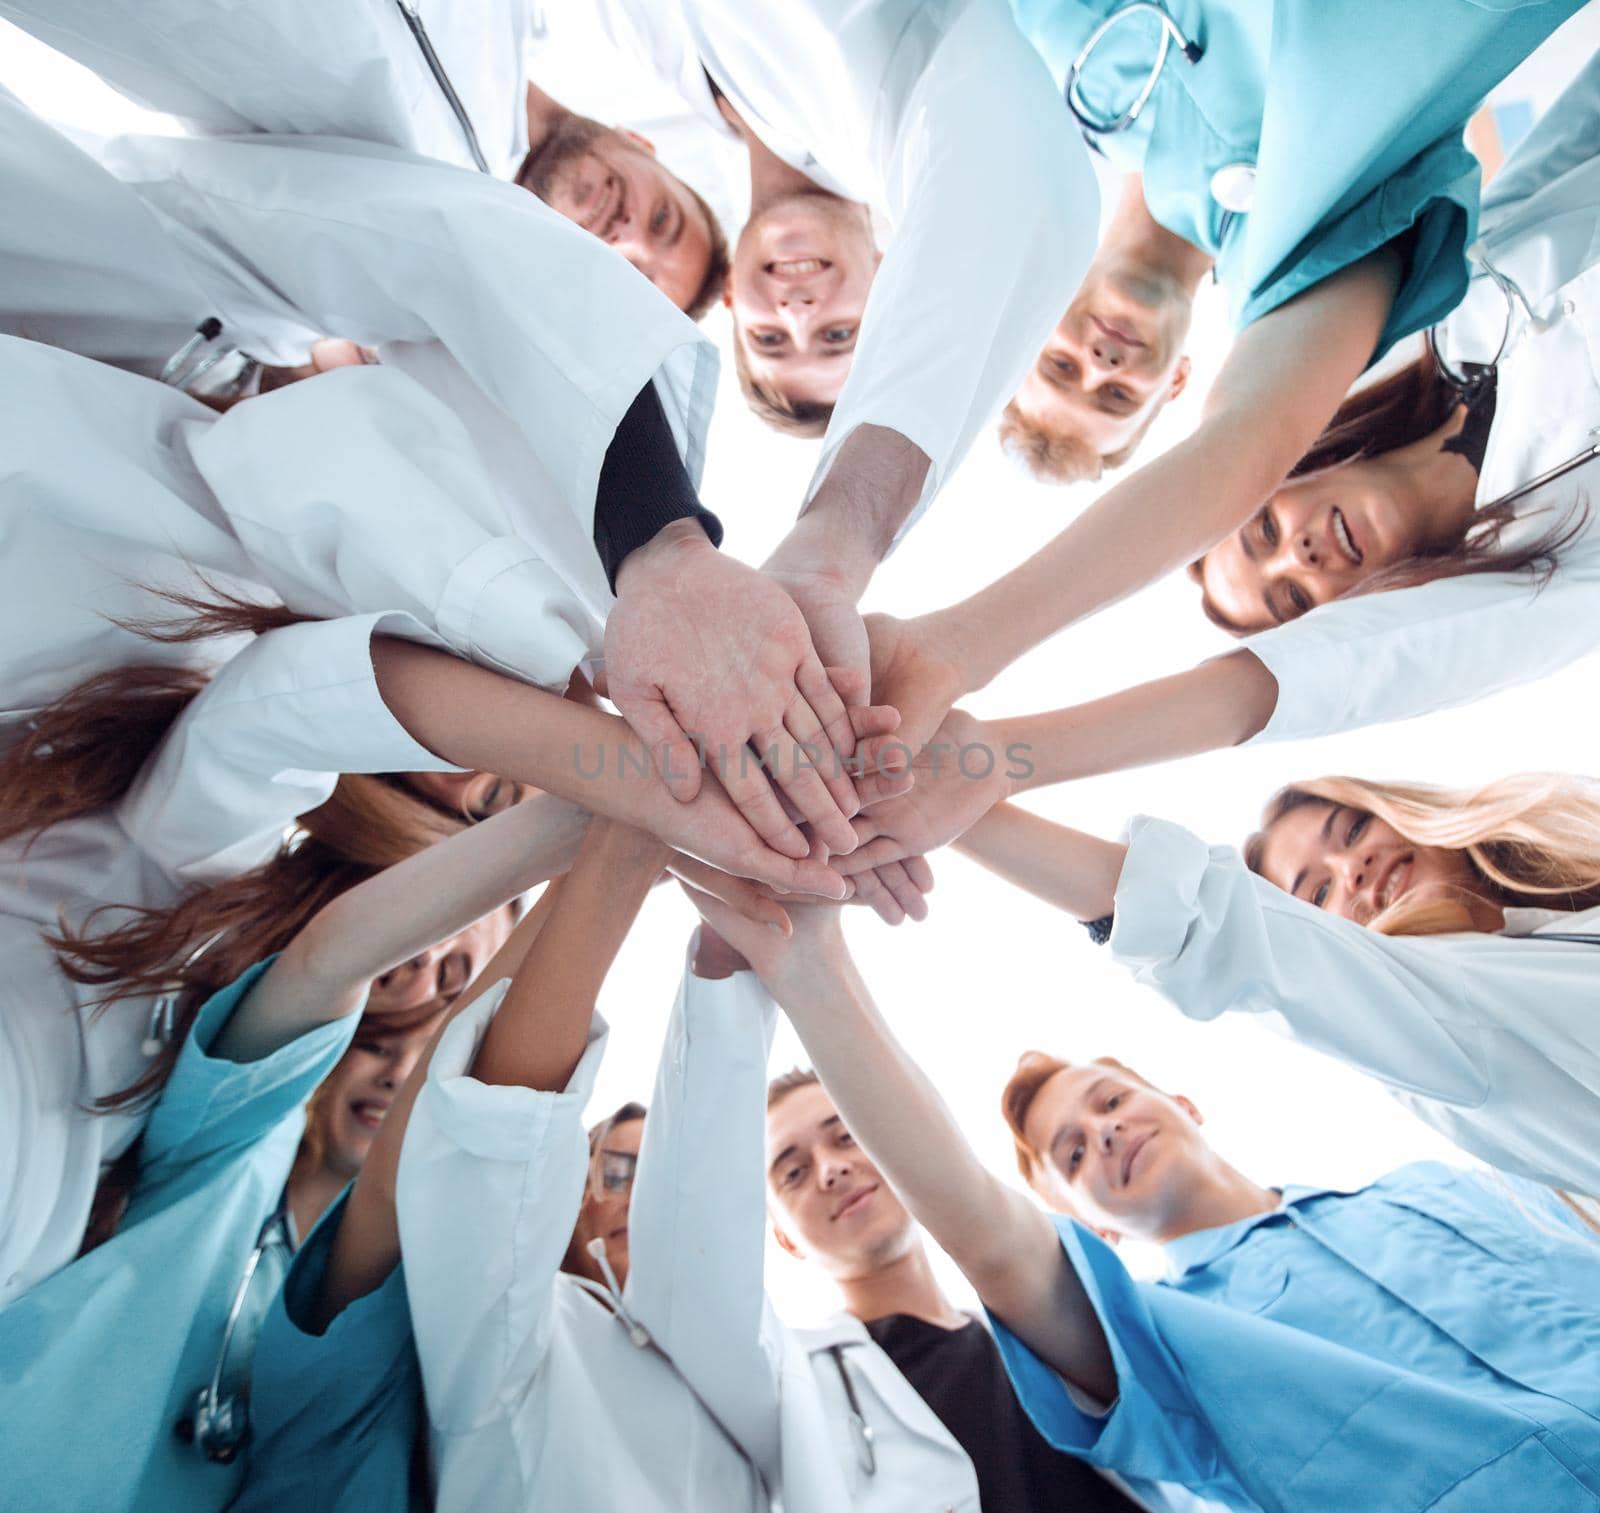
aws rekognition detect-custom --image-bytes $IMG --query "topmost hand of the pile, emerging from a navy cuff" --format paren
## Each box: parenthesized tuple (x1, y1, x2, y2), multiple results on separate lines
(605, 521, 859, 859)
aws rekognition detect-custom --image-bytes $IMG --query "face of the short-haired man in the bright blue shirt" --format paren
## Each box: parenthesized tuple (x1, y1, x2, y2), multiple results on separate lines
(1022, 1062, 1213, 1240)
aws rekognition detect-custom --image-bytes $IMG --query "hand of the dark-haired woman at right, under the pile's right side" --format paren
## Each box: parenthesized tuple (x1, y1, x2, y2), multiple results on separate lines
(835, 709, 1011, 870)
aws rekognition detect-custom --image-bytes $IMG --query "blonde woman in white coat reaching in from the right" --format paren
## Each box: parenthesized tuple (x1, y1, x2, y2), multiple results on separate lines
(958, 774, 1600, 1198)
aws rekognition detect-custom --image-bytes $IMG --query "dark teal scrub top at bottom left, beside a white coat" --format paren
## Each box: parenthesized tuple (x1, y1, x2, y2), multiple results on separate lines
(229, 1188, 430, 1513)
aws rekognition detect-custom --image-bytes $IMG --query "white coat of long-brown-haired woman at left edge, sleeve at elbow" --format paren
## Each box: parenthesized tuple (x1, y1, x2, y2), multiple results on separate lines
(0, 614, 454, 1305)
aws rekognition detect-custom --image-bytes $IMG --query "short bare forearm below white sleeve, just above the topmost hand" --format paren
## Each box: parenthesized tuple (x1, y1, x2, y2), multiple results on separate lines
(765, 425, 928, 598)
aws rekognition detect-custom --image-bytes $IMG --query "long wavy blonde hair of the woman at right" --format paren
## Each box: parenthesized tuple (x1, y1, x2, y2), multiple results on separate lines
(1245, 772, 1600, 936)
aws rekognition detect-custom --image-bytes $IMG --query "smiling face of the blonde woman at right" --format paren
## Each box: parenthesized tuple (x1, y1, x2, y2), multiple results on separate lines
(1256, 800, 1485, 924)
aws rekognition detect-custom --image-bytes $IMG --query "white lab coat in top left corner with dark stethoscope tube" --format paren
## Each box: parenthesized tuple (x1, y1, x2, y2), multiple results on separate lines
(0, 0, 531, 178)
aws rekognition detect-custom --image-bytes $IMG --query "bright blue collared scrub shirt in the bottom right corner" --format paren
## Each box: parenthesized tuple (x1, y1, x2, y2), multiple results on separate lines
(995, 1163, 1600, 1513)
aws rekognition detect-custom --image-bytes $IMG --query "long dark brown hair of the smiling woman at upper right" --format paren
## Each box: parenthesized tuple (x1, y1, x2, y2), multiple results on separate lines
(1202, 350, 1589, 635)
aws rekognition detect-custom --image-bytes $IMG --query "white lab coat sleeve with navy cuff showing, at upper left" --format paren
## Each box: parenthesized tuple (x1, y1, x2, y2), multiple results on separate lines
(0, 96, 717, 582)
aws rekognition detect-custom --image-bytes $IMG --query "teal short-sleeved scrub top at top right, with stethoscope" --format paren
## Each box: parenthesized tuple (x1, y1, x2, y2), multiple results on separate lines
(1011, 0, 1582, 361)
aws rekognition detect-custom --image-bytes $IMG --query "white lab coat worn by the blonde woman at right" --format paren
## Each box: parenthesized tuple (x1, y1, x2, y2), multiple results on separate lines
(1110, 816, 1600, 1196)
